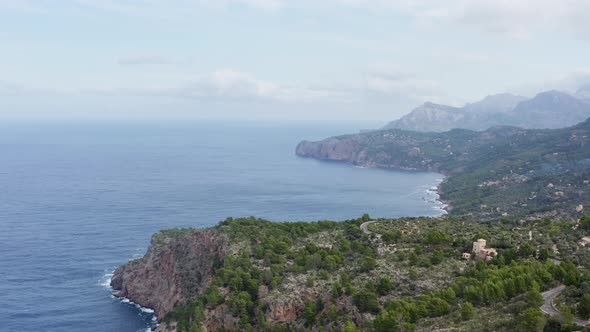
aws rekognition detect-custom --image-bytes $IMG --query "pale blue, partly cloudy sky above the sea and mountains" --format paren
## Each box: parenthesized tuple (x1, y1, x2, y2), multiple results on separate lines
(0, 0, 590, 123)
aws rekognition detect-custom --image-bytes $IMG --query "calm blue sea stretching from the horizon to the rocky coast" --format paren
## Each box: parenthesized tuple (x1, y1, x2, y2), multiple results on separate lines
(0, 122, 441, 331)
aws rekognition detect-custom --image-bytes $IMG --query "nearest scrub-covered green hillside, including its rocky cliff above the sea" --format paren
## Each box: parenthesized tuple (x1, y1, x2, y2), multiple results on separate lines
(112, 215, 590, 332)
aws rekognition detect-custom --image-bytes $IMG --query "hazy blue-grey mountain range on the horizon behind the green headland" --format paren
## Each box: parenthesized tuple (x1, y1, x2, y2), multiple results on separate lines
(383, 91, 590, 132)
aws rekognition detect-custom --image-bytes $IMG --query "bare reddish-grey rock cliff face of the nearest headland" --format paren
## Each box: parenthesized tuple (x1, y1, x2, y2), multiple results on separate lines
(111, 230, 227, 318)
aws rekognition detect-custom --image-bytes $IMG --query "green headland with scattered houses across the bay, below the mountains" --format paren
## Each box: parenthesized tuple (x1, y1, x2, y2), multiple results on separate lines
(296, 120, 590, 219)
